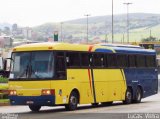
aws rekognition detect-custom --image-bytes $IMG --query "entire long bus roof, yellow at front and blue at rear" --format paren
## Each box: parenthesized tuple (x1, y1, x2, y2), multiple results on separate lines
(13, 42, 156, 55)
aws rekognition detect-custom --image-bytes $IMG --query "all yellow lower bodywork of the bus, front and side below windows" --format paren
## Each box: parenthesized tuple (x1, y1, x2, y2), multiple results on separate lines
(9, 69, 126, 104)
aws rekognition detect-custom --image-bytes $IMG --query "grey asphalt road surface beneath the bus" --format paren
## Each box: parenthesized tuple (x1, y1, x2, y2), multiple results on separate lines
(0, 94, 160, 119)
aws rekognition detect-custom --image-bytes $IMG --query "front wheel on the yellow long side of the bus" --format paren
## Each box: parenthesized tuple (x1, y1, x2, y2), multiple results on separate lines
(65, 91, 78, 111)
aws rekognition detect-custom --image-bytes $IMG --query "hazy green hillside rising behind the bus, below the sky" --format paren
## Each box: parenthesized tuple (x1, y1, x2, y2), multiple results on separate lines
(33, 13, 160, 42)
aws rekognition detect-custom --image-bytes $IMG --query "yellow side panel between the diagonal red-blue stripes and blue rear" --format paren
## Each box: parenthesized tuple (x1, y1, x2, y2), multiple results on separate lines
(94, 69, 126, 102)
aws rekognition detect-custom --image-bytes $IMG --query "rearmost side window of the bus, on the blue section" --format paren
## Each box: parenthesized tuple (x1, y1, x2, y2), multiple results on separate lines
(146, 56, 156, 67)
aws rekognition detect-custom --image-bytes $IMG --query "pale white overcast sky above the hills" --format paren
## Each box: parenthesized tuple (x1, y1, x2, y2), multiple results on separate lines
(0, 0, 160, 26)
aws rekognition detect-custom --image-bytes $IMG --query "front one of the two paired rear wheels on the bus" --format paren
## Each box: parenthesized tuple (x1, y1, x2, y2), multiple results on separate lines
(123, 88, 132, 104)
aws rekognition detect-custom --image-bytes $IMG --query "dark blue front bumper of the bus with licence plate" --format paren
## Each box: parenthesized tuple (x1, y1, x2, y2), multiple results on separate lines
(9, 95, 55, 106)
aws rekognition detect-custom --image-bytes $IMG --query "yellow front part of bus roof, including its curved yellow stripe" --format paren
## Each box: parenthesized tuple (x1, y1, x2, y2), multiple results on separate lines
(13, 42, 114, 52)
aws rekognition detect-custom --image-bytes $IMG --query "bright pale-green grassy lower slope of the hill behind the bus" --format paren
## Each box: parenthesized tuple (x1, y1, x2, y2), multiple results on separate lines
(72, 25, 160, 42)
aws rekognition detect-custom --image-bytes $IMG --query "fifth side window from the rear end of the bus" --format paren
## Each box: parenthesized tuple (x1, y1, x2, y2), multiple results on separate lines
(107, 54, 117, 68)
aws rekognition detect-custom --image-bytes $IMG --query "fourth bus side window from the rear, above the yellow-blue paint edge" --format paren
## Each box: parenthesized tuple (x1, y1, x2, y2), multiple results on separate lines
(117, 54, 128, 68)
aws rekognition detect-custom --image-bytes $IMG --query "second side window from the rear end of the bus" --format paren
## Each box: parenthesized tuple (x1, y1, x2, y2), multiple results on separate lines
(136, 55, 146, 67)
